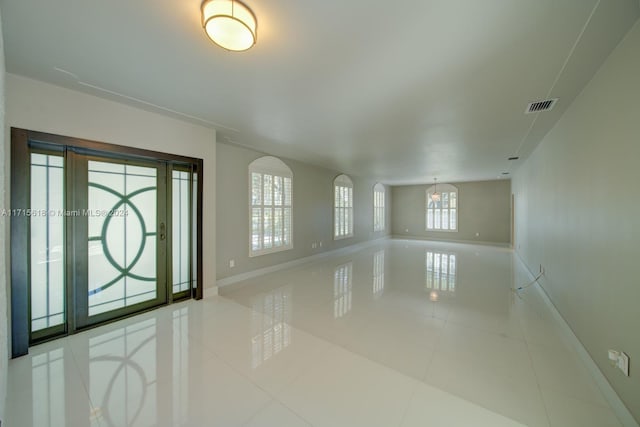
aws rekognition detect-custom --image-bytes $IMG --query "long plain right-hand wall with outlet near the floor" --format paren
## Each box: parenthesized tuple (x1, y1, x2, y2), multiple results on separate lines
(513, 22, 640, 421)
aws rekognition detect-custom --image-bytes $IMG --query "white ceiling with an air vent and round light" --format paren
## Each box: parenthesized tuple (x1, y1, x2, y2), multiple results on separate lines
(0, 0, 640, 184)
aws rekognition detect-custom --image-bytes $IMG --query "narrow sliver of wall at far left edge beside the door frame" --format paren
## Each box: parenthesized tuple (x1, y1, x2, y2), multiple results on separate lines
(0, 6, 9, 420)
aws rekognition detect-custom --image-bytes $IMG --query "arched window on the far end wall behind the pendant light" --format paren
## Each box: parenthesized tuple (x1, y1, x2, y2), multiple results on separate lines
(426, 184, 458, 231)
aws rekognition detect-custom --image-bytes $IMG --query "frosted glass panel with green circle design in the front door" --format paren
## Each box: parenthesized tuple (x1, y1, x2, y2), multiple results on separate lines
(88, 161, 158, 316)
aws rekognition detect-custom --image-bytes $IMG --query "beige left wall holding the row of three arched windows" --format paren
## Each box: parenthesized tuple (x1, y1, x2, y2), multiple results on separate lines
(216, 143, 391, 279)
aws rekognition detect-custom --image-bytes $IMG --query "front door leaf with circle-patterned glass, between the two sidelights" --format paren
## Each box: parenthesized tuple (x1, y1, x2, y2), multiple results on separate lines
(75, 156, 168, 327)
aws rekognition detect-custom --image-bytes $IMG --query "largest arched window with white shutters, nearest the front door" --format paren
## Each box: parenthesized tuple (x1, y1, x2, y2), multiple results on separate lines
(249, 156, 293, 256)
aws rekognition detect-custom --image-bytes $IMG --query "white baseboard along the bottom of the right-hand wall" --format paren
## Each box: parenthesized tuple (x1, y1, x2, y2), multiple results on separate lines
(514, 251, 640, 427)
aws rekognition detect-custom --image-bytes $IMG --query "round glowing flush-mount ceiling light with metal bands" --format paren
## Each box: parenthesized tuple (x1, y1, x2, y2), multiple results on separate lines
(201, 0, 258, 52)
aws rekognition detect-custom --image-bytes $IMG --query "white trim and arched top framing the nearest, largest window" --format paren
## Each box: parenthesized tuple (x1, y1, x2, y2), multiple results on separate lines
(247, 156, 293, 258)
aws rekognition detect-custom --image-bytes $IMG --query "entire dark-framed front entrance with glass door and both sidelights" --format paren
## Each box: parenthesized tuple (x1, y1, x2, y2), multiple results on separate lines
(10, 129, 202, 357)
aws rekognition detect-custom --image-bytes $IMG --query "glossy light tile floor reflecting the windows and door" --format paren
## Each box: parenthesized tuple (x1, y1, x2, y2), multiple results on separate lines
(3, 240, 620, 427)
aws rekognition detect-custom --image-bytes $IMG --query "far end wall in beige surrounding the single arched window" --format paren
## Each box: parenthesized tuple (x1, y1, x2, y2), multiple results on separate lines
(391, 180, 511, 244)
